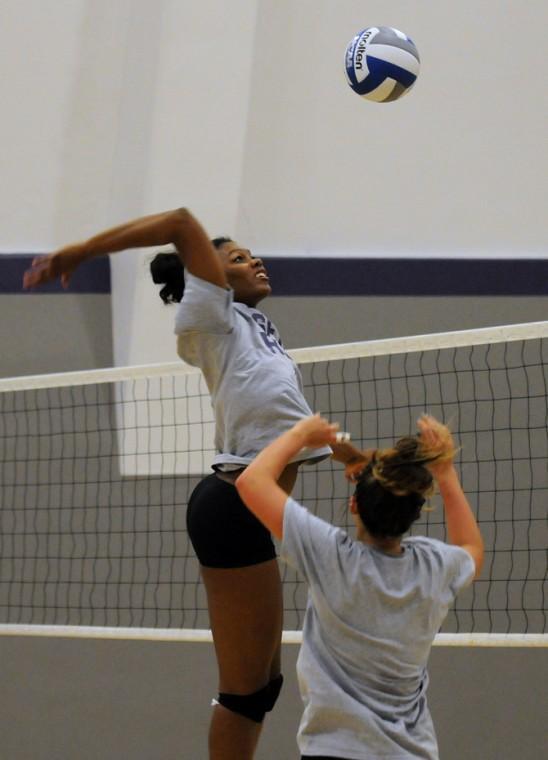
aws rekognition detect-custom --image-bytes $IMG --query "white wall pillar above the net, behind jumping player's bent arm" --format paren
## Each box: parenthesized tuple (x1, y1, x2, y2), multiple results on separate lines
(126, 0, 257, 364)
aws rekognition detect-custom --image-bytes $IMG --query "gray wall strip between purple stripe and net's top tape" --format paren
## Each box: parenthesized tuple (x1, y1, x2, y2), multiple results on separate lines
(0, 293, 548, 377)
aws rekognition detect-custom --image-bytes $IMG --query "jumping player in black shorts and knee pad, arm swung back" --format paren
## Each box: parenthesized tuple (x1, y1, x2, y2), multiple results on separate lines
(24, 209, 330, 760)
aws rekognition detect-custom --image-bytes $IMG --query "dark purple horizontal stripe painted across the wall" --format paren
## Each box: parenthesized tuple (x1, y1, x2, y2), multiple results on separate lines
(0, 254, 548, 296)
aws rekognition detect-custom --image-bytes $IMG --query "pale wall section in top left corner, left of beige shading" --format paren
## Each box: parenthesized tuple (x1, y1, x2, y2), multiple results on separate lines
(0, 0, 86, 251)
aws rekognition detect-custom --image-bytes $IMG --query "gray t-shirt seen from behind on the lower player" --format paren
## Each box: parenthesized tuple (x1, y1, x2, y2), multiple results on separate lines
(281, 498, 474, 760)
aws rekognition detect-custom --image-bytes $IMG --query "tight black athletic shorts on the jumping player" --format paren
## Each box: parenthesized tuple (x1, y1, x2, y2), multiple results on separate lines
(186, 475, 276, 568)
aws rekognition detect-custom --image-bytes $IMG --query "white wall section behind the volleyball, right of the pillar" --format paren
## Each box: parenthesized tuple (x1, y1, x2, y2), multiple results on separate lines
(238, 0, 548, 254)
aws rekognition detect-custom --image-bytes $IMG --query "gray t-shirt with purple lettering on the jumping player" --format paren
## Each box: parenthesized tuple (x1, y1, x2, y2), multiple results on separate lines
(175, 272, 331, 469)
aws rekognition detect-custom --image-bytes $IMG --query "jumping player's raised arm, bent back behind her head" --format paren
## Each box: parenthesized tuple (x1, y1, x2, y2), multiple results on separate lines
(23, 208, 227, 288)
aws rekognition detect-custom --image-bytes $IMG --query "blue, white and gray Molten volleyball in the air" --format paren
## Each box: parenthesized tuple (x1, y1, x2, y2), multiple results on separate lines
(344, 26, 420, 103)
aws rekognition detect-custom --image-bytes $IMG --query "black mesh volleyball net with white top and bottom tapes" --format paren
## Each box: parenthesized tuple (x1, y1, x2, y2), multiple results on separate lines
(0, 322, 548, 645)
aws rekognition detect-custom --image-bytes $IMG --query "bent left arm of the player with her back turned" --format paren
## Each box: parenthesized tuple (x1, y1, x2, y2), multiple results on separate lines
(236, 414, 339, 539)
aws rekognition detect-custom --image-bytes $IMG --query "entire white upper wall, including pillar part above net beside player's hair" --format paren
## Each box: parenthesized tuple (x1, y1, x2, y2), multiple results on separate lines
(0, 0, 548, 364)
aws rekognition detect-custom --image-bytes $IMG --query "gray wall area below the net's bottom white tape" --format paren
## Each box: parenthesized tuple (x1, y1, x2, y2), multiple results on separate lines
(0, 638, 548, 760)
